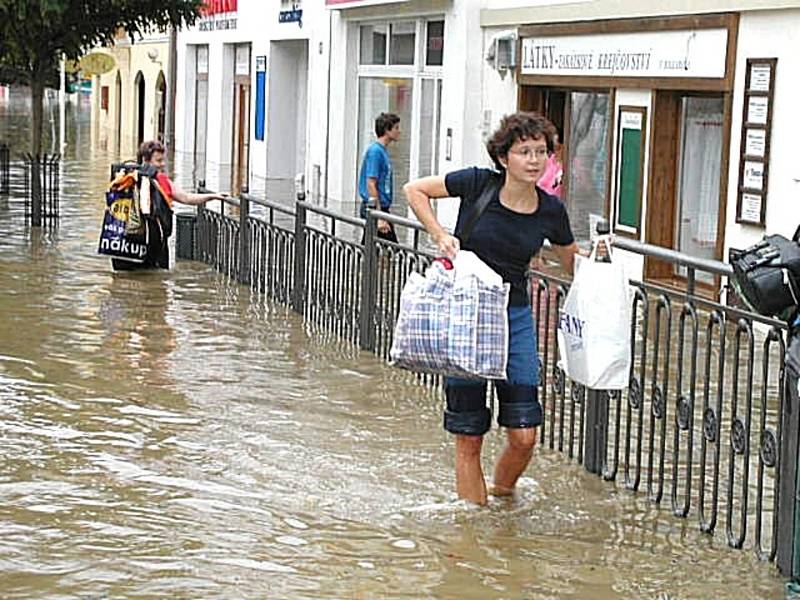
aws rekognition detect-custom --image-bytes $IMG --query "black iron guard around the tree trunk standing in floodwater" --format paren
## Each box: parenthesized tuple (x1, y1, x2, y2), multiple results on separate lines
(23, 154, 61, 227)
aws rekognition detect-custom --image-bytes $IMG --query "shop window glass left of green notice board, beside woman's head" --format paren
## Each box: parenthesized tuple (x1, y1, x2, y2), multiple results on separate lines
(565, 92, 609, 240)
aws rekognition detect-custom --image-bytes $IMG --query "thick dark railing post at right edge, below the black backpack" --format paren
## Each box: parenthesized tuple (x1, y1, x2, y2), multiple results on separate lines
(775, 343, 800, 579)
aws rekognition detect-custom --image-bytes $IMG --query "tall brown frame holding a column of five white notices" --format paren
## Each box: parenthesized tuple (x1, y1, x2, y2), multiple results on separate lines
(736, 58, 778, 227)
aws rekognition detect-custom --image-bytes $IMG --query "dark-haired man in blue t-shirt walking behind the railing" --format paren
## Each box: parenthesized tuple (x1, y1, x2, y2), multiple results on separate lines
(358, 113, 400, 242)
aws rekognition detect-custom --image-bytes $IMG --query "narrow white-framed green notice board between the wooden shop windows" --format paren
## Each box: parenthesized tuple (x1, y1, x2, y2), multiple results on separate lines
(614, 106, 647, 239)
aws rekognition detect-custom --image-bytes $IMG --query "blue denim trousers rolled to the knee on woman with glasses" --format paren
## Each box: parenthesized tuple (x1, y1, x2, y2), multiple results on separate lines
(444, 306, 543, 435)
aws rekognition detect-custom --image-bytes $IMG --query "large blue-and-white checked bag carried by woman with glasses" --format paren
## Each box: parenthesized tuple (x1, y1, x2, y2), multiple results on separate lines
(389, 250, 509, 379)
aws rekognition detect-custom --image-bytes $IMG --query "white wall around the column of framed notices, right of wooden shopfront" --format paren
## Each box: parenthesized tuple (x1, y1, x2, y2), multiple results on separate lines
(725, 10, 800, 258)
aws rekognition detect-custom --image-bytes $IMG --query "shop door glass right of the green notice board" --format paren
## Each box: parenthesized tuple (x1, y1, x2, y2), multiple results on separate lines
(676, 97, 724, 283)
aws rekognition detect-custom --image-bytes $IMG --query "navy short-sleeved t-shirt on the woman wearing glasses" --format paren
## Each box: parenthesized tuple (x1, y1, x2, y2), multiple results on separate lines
(444, 167, 575, 306)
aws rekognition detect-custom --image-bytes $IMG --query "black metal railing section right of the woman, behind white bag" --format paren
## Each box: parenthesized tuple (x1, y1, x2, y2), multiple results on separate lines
(531, 239, 797, 572)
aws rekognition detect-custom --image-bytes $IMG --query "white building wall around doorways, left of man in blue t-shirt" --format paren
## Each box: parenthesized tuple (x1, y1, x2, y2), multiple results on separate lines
(175, 0, 329, 191)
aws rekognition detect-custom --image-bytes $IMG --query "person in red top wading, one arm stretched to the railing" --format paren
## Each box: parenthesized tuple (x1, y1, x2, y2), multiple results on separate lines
(111, 140, 225, 271)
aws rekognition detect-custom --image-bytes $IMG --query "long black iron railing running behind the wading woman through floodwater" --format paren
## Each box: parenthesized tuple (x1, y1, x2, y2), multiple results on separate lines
(183, 186, 800, 574)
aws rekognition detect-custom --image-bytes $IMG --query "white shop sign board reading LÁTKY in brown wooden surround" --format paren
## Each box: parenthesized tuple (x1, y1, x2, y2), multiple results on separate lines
(521, 28, 728, 78)
